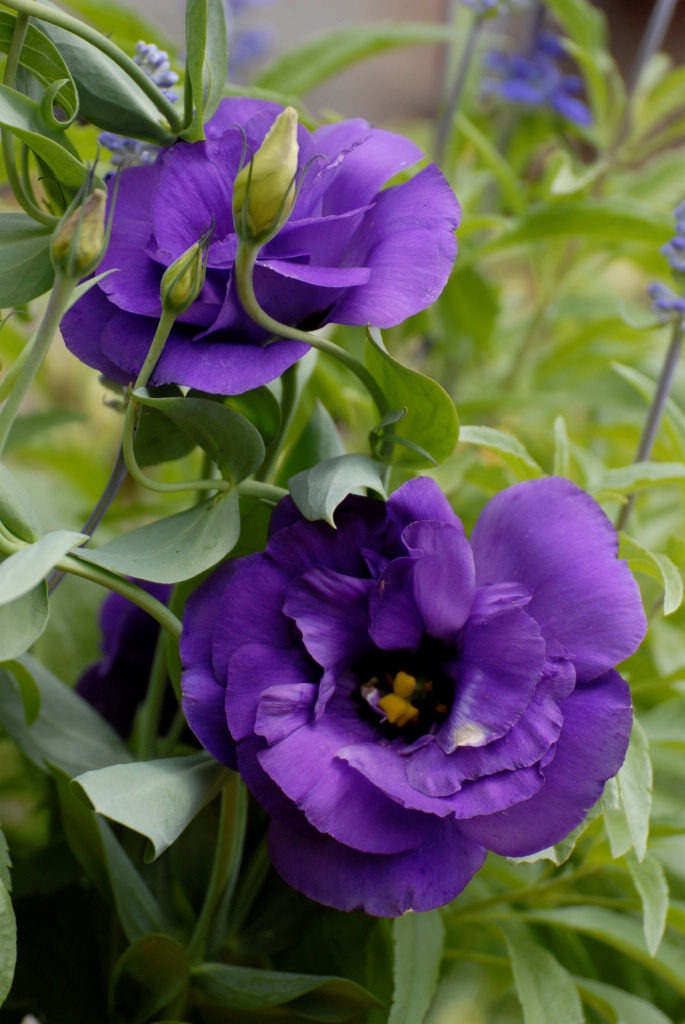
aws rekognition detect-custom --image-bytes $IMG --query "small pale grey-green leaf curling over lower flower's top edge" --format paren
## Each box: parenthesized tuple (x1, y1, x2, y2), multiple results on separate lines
(288, 455, 386, 527)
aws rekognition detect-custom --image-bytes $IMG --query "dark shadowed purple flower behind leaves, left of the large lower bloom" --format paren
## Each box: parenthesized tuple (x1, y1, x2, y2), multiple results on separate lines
(76, 581, 170, 736)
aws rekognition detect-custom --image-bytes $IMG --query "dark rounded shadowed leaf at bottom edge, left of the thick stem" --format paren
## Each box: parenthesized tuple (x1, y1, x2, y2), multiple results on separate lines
(112, 935, 190, 1024)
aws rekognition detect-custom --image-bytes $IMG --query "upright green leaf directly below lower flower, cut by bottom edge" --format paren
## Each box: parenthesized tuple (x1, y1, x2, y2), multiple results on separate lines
(388, 910, 444, 1024)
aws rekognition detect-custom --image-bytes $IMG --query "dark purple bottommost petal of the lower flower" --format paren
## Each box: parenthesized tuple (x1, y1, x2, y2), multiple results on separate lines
(268, 821, 485, 918)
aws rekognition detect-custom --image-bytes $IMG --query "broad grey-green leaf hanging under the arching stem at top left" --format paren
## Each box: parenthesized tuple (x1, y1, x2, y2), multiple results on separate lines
(35, 22, 175, 145)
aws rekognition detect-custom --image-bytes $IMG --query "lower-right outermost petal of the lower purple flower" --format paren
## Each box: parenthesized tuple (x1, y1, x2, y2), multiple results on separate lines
(462, 672, 633, 857)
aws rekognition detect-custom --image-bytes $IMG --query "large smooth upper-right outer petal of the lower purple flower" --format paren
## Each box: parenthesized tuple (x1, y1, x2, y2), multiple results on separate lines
(471, 477, 646, 682)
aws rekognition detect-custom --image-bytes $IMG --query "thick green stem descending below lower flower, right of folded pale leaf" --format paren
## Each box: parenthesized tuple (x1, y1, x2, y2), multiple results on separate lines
(187, 774, 247, 964)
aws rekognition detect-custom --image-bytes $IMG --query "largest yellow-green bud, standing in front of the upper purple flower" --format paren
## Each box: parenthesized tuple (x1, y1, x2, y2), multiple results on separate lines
(233, 106, 299, 243)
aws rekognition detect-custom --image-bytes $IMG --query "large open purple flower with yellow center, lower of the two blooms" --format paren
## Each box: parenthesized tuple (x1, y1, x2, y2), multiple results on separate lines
(181, 477, 645, 915)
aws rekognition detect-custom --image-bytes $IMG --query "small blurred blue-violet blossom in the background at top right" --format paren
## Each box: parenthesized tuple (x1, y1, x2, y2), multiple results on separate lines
(484, 32, 592, 127)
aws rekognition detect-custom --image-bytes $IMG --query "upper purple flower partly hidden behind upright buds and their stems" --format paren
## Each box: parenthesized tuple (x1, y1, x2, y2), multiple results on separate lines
(62, 99, 460, 394)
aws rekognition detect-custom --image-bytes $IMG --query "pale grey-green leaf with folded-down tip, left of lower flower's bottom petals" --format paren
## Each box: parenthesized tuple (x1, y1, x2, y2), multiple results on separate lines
(72, 753, 226, 861)
